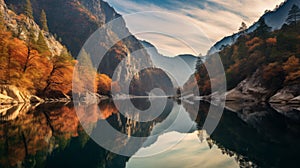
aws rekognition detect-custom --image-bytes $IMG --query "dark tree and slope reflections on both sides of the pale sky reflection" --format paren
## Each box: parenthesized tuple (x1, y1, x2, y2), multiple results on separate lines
(0, 100, 300, 167)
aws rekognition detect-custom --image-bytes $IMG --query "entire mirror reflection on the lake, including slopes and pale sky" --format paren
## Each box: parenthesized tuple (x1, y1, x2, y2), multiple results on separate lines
(0, 100, 300, 167)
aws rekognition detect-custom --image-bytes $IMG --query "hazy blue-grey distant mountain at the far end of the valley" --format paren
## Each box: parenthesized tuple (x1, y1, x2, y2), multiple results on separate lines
(142, 41, 197, 86)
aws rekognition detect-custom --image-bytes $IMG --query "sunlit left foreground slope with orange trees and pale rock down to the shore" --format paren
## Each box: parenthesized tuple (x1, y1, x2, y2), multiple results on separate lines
(0, 0, 78, 97)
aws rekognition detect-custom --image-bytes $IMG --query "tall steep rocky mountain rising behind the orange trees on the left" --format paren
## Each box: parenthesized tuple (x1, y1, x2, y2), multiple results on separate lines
(5, 0, 178, 94)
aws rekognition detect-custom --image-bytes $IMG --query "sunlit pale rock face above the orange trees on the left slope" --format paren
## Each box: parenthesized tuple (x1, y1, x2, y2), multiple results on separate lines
(0, 0, 63, 55)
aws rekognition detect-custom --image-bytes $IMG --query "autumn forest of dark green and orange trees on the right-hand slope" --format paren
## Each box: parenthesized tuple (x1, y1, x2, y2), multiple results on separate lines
(195, 5, 300, 95)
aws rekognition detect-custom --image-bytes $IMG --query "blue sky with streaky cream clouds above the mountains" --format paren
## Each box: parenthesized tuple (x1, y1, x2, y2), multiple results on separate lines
(106, 0, 284, 56)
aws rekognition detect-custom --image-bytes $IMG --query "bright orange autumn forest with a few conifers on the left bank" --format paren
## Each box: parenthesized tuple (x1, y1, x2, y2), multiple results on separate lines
(0, 0, 111, 97)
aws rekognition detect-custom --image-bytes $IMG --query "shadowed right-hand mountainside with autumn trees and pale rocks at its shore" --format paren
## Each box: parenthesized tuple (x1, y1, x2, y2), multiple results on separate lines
(191, 0, 300, 107)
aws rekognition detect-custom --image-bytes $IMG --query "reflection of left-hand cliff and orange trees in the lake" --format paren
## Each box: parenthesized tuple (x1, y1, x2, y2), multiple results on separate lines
(0, 100, 171, 167)
